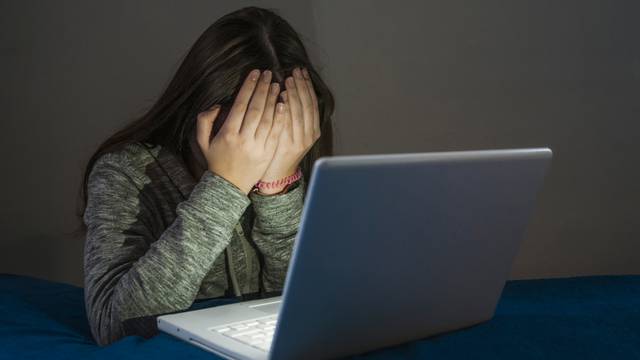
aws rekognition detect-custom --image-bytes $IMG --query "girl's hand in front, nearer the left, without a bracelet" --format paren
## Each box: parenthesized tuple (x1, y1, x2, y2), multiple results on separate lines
(197, 69, 284, 194)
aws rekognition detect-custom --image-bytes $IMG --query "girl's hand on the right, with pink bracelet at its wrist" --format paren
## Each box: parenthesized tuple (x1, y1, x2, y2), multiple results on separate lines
(260, 68, 320, 193)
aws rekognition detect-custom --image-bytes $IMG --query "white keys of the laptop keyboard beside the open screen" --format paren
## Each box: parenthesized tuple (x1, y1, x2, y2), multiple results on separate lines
(211, 314, 278, 351)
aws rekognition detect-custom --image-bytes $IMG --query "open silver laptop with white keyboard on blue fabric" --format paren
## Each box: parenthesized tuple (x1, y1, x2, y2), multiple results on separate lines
(157, 148, 552, 359)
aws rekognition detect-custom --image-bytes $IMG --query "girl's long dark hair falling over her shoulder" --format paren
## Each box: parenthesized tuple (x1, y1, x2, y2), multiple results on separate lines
(72, 6, 334, 235)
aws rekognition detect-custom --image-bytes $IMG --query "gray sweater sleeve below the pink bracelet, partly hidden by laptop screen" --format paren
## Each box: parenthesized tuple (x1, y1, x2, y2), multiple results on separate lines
(249, 177, 306, 292)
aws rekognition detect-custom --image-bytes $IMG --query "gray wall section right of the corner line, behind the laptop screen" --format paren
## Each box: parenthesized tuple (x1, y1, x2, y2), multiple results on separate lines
(314, 0, 640, 278)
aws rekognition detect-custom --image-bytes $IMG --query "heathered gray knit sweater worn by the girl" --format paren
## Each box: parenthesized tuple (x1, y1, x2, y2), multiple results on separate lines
(84, 143, 305, 345)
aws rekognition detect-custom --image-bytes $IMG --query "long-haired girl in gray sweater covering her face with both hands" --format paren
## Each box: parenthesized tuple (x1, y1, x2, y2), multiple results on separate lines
(75, 7, 334, 345)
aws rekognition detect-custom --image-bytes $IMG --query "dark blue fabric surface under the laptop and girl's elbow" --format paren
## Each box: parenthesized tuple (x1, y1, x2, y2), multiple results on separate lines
(0, 275, 640, 360)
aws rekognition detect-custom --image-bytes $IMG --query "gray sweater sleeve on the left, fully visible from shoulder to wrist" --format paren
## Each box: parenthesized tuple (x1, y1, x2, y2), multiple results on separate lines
(84, 153, 250, 345)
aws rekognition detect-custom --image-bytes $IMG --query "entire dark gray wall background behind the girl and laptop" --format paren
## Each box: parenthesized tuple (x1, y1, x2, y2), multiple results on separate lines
(0, 0, 640, 284)
